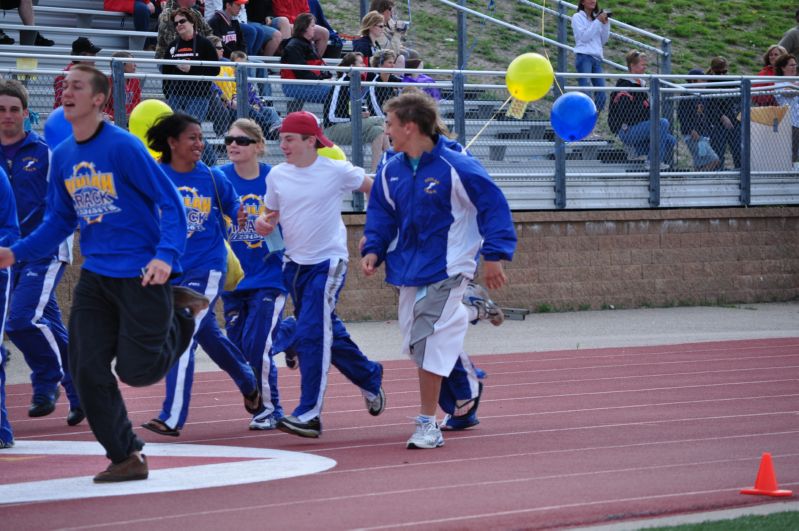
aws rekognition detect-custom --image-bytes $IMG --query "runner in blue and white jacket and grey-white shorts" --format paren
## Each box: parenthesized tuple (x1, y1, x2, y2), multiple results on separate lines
(361, 93, 516, 448)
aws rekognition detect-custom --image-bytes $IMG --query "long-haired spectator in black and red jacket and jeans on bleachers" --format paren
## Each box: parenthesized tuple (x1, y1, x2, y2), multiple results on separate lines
(280, 13, 333, 103)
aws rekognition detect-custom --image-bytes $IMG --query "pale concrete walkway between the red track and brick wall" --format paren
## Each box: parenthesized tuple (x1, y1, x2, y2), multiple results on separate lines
(5, 302, 799, 384)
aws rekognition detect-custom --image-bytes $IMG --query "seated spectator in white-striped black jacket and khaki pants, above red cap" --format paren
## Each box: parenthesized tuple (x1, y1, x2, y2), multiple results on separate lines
(322, 52, 388, 172)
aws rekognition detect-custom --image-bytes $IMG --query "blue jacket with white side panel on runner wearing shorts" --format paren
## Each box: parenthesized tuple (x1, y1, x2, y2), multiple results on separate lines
(361, 137, 516, 286)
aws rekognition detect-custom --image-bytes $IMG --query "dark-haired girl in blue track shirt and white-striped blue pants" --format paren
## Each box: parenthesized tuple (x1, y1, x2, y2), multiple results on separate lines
(142, 112, 262, 437)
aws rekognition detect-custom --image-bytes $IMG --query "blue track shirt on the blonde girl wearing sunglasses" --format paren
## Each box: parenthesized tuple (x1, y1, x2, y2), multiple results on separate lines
(219, 163, 286, 291)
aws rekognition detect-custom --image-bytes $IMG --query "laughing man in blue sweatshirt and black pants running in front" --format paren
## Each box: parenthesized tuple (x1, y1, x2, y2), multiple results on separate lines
(0, 65, 208, 483)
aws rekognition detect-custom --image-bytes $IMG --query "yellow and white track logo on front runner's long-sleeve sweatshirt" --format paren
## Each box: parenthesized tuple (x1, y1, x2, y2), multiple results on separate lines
(64, 162, 121, 223)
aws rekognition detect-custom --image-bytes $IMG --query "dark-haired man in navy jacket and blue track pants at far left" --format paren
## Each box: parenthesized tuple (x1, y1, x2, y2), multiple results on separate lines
(0, 80, 85, 426)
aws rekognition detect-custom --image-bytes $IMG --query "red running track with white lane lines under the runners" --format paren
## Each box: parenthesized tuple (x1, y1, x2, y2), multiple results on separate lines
(0, 338, 799, 531)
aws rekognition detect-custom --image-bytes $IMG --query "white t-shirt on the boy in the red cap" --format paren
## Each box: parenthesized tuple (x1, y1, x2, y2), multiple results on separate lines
(264, 157, 364, 265)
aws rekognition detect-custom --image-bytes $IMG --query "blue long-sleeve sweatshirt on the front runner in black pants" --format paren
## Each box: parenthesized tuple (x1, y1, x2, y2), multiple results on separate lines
(11, 123, 186, 278)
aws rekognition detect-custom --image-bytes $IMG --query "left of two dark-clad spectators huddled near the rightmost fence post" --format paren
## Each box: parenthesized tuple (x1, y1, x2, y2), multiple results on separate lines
(677, 68, 720, 171)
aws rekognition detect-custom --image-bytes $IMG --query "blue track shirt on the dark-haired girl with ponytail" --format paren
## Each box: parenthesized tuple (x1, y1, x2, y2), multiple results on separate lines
(161, 162, 240, 271)
